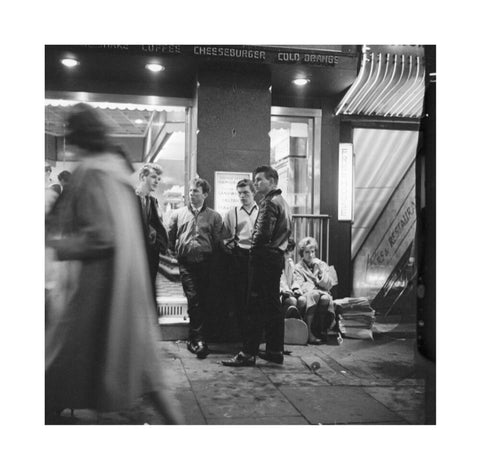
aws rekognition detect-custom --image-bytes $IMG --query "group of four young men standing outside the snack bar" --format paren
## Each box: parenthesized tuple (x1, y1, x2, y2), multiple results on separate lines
(137, 164, 292, 367)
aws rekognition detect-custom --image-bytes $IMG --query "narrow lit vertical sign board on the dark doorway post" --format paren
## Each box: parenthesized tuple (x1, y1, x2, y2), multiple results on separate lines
(338, 143, 354, 221)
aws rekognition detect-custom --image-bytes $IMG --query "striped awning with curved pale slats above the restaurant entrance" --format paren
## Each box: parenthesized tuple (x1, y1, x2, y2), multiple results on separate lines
(335, 47, 425, 118)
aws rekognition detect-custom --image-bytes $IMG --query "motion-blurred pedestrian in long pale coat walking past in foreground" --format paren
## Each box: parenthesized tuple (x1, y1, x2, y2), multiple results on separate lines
(45, 104, 181, 424)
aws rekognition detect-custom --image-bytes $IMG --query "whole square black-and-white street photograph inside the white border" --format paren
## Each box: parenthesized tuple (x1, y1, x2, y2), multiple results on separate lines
(45, 44, 436, 425)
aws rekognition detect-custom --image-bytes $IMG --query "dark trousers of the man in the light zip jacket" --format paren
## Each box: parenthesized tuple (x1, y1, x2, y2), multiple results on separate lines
(178, 260, 211, 341)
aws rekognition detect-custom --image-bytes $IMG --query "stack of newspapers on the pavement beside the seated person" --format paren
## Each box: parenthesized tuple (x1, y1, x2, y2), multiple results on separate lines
(334, 297, 375, 340)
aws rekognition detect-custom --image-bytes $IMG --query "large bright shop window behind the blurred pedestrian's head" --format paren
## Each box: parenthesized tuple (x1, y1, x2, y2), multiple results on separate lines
(45, 92, 191, 308)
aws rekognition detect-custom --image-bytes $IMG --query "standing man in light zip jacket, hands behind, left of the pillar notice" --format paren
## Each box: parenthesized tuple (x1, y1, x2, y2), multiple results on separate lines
(168, 177, 222, 358)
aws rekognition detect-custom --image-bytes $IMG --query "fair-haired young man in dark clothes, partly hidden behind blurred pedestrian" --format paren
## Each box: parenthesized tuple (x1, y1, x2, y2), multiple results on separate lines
(135, 163, 168, 294)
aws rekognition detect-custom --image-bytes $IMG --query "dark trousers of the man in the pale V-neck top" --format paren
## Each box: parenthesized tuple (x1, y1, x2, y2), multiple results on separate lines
(228, 247, 250, 341)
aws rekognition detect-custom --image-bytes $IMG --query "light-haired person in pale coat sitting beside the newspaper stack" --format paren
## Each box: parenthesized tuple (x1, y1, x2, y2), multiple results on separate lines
(293, 237, 338, 344)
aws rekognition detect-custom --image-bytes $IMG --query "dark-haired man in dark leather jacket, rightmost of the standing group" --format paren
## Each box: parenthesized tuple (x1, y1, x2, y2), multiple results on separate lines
(222, 166, 292, 367)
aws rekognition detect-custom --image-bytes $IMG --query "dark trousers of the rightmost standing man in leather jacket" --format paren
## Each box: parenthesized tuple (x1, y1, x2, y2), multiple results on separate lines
(243, 250, 285, 355)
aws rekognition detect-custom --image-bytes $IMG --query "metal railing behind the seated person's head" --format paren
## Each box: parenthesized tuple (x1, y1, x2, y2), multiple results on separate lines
(292, 213, 330, 264)
